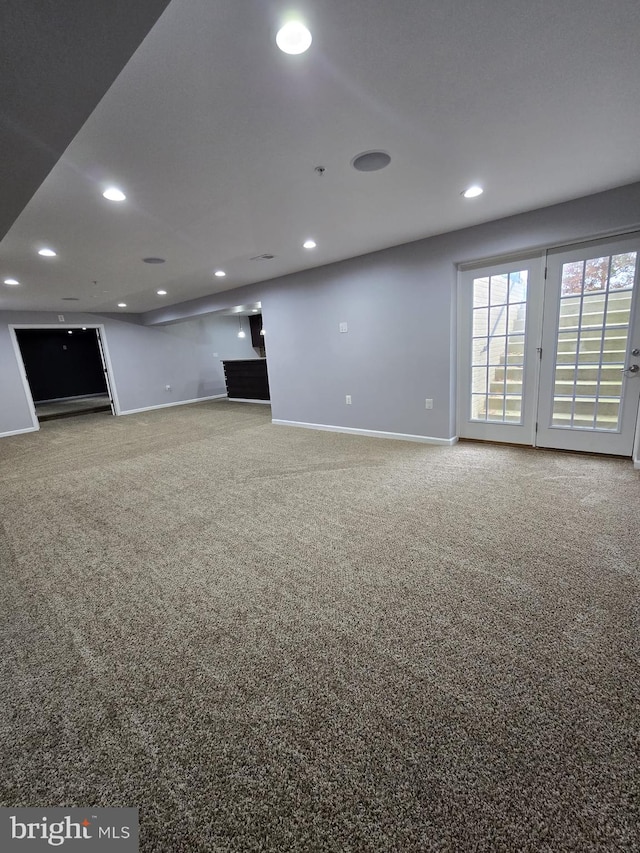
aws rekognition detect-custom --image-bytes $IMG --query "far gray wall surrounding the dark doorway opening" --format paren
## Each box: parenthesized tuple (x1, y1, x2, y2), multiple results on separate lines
(0, 311, 256, 435)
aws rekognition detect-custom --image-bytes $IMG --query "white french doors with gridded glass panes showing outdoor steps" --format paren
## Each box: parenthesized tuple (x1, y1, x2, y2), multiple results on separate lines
(458, 234, 640, 456)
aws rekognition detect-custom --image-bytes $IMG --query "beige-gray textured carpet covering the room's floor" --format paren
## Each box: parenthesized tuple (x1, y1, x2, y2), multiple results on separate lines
(0, 400, 640, 853)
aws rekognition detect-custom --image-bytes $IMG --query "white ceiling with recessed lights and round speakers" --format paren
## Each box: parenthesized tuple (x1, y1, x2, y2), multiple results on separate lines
(0, 0, 640, 312)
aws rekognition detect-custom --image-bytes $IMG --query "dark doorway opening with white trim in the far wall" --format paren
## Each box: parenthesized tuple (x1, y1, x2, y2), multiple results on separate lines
(11, 326, 116, 426)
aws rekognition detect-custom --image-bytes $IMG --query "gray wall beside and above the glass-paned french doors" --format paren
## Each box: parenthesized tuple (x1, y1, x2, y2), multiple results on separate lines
(258, 179, 640, 432)
